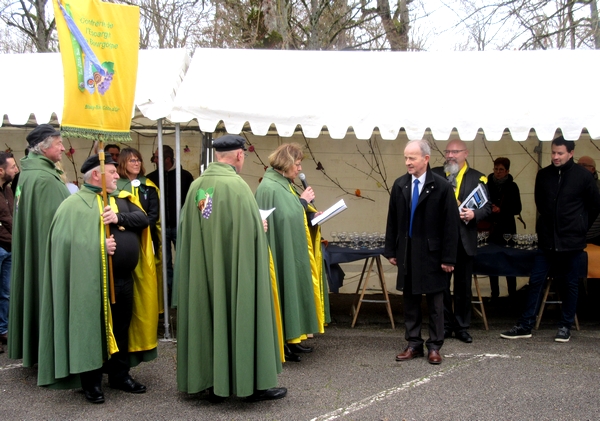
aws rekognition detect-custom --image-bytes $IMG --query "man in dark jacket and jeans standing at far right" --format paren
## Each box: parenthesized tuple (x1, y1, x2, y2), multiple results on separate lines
(500, 136, 600, 342)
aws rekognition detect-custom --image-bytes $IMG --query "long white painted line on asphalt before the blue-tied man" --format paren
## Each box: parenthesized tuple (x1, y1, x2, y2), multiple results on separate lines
(311, 354, 521, 421)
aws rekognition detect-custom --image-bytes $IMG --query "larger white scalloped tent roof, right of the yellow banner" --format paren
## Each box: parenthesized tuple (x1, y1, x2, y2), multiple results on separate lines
(169, 49, 600, 140)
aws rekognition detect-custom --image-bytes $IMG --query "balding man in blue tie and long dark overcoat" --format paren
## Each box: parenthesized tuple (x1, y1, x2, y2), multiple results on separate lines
(384, 140, 459, 364)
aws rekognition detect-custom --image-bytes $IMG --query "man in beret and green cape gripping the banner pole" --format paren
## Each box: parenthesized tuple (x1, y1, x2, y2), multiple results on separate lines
(38, 155, 158, 403)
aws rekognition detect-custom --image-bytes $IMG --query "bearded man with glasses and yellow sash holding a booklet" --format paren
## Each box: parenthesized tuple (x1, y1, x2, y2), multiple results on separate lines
(432, 139, 492, 343)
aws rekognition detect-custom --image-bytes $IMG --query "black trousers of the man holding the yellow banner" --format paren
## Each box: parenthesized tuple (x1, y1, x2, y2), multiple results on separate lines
(80, 274, 133, 390)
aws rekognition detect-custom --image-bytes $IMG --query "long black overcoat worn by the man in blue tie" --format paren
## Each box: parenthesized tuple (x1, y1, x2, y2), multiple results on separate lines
(384, 168, 460, 294)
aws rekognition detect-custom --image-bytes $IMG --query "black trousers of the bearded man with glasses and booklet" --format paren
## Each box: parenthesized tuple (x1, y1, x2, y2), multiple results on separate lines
(444, 241, 473, 332)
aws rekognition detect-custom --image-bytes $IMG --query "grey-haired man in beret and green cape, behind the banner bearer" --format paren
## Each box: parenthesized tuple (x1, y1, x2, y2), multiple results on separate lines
(8, 124, 69, 367)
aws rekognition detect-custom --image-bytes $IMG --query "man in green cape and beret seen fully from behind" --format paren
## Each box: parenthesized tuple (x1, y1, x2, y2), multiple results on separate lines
(173, 135, 287, 402)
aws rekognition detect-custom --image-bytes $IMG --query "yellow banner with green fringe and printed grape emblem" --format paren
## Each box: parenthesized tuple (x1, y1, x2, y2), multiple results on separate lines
(53, 0, 140, 142)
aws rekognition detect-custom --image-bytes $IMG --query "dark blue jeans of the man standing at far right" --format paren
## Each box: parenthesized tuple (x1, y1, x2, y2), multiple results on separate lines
(517, 250, 583, 330)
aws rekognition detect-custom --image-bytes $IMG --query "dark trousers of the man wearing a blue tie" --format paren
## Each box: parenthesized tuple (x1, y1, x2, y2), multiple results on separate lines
(403, 241, 444, 351)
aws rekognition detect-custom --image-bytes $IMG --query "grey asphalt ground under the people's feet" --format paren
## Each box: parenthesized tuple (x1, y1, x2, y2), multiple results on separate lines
(0, 293, 600, 420)
